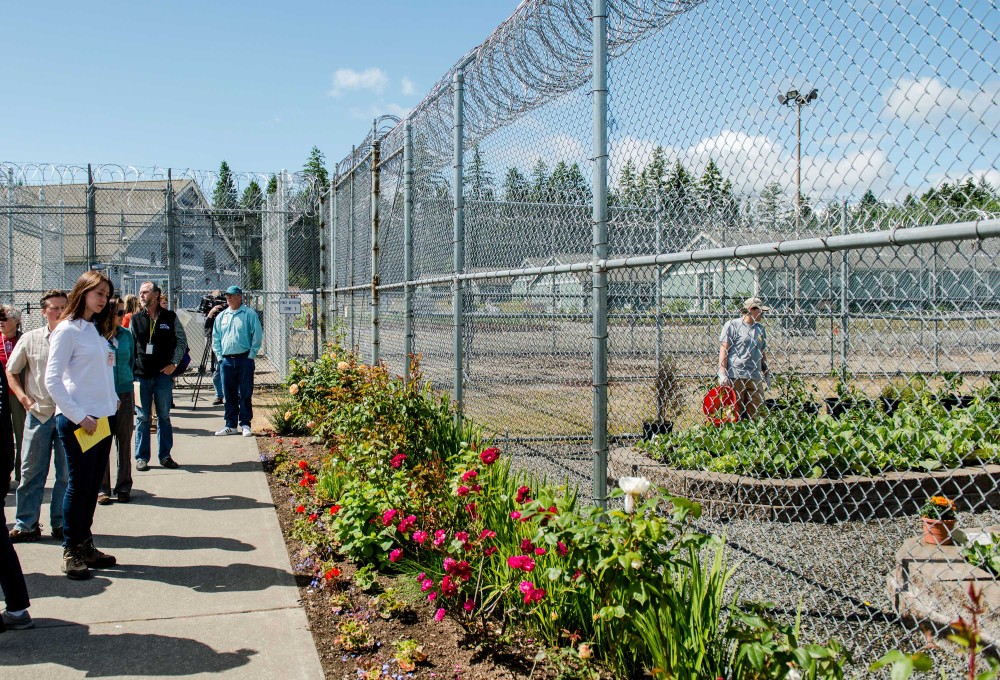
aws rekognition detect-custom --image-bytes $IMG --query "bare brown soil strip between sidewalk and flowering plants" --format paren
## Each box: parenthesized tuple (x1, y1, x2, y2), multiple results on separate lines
(258, 436, 554, 680)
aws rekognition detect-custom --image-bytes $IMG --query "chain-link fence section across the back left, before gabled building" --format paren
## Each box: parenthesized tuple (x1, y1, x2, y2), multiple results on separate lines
(0, 163, 325, 384)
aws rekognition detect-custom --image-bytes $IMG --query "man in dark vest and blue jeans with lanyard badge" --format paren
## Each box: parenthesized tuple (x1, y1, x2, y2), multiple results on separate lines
(129, 281, 187, 471)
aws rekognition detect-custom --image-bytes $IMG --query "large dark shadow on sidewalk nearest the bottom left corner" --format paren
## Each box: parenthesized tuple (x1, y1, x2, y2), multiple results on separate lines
(0, 618, 257, 678)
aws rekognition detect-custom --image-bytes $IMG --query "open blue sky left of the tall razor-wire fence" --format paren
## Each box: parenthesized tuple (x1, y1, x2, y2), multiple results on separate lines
(0, 0, 518, 172)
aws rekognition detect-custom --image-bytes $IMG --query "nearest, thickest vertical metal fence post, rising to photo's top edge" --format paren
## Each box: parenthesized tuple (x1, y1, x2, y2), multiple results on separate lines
(592, 0, 608, 508)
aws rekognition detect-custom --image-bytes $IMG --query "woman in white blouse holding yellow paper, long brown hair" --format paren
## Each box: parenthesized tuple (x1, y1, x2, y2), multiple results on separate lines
(45, 271, 118, 579)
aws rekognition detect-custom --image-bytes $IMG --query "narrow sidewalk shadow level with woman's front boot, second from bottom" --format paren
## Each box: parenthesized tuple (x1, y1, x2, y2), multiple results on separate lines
(101, 563, 292, 593)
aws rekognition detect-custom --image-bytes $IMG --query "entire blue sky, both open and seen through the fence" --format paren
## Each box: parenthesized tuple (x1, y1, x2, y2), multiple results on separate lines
(0, 0, 1000, 201)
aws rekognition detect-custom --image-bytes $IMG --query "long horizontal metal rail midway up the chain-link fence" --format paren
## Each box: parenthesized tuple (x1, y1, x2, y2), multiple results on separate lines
(334, 219, 1000, 293)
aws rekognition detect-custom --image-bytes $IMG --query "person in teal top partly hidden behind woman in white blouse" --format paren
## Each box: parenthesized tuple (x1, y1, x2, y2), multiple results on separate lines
(97, 296, 135, 505)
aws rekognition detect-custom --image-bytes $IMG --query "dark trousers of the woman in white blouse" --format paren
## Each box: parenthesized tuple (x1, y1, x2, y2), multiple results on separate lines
(56, 413, 117, 548)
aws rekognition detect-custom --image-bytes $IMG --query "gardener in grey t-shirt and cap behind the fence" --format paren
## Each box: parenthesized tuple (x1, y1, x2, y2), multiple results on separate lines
(719, 297, 771, 420)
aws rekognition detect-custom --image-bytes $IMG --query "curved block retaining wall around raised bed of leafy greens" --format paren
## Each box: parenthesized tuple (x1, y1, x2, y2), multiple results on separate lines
(608, 447, 1000, 523)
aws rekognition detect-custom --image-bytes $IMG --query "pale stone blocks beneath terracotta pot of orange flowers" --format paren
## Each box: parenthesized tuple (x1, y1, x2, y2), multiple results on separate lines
(886, 526, 1000, 651)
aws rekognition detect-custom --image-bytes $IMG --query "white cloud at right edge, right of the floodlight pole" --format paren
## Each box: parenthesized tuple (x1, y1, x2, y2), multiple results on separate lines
(884, 77, 1000, 136)
